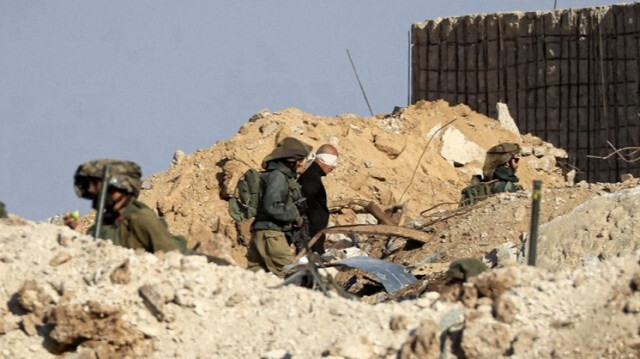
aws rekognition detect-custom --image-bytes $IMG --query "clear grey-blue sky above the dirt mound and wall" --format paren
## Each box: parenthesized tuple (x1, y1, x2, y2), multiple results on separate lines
(0, 0, 621, 220)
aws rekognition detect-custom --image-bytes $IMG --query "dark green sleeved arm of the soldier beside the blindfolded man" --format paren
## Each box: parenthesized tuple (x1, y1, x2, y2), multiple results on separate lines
(262, 172, 300, 223)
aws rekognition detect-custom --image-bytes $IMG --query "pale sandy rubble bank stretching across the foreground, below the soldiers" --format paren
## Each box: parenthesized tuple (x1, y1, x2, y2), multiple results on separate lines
(0, 188, 640, 358)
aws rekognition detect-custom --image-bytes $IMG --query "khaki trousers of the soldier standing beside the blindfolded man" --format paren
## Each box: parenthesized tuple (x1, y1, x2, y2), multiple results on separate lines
(247, 229, 295, 277)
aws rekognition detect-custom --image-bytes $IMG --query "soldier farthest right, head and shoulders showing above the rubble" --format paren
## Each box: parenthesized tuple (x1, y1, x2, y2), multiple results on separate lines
(483, 143, 522, 193)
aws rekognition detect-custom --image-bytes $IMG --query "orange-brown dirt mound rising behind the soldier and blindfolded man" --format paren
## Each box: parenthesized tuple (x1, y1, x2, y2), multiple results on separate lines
(141, 101, 566, 265)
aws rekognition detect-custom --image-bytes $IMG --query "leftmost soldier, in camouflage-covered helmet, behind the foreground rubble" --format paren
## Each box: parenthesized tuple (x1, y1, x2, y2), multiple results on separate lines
(63, 159, 186, 253)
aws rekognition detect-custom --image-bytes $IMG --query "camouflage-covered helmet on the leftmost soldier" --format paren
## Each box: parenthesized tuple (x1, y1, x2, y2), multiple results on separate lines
(73, 158, 142, 199)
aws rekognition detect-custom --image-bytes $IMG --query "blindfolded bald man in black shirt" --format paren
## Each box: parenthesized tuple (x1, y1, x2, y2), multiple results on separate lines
(298, 144, 338, 254)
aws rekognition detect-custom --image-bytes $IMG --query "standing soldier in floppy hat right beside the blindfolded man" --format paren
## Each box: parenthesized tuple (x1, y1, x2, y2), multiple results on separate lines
(247, 137, 311, 276)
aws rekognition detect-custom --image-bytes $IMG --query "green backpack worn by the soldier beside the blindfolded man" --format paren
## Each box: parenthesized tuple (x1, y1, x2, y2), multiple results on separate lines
(229, 168, 262, 222)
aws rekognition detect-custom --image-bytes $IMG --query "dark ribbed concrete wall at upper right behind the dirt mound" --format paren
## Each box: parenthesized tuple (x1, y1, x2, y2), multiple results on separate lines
(411, 3, 640, 181)
